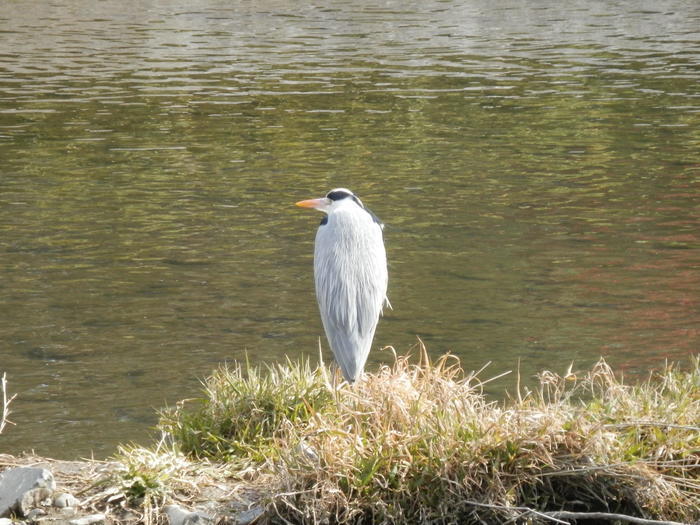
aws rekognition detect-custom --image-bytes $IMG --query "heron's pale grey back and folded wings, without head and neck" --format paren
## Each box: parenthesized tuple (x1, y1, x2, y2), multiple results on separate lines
(314, 219, 387, 381)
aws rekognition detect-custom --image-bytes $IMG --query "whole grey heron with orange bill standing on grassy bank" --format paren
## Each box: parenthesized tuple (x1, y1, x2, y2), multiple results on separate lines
(296, 188, 389, 383)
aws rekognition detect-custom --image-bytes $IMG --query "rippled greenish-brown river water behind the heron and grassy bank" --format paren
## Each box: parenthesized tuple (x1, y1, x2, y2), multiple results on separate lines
(0, 0, 700, 458)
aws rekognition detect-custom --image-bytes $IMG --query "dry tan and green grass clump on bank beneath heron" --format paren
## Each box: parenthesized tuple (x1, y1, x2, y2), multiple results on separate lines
(149, 347, 700, 523)
